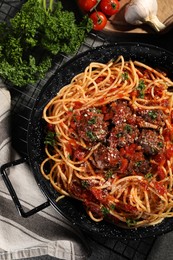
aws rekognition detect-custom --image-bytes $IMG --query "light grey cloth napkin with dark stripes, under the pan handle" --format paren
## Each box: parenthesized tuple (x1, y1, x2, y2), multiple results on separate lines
(0, 82, 88, 260)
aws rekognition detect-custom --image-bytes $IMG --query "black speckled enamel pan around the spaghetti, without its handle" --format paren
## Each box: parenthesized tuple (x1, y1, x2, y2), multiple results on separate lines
(27, 43, 173, 239)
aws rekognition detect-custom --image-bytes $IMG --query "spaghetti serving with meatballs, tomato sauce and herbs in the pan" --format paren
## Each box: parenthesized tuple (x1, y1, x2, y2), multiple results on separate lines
(40, 56, 173, 227)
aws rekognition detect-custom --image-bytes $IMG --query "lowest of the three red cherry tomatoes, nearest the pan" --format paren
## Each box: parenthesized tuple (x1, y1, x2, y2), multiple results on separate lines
(89, 11, 107, 31)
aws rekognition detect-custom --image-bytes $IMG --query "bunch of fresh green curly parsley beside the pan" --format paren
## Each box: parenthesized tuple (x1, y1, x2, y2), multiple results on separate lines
(0, 0, 92, 86)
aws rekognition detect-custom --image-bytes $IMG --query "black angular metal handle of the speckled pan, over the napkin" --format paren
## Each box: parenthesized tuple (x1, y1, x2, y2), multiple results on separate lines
(1, 158, 50, 218)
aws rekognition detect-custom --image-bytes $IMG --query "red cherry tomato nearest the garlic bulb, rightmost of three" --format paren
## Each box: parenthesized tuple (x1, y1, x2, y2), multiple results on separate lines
(99, 0, 120, 16)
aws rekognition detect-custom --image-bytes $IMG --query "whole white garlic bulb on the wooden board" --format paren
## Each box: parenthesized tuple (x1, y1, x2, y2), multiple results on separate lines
(124, 0, 165, 32)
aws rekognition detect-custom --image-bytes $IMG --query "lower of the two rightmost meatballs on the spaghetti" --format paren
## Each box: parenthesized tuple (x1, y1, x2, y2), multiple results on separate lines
(137, 129, 164, 155)
